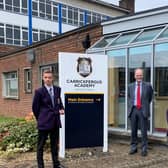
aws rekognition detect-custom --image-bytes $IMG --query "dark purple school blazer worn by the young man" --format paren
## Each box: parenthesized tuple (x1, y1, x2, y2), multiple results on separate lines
(32, 86, 64, 130)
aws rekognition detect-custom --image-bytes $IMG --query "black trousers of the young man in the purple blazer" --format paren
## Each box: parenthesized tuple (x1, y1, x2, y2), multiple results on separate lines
(37, 128, 59, 168)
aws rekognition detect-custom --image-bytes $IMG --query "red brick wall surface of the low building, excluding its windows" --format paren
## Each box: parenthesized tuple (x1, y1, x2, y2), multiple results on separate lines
(0, 25, 102, 117)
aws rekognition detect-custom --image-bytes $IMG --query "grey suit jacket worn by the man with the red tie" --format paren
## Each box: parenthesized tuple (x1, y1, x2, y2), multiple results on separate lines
(128, 81, 153, 118)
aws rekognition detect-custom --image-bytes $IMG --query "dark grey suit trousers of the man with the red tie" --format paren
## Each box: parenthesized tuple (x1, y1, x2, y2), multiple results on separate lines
(130, 107, 148, 151)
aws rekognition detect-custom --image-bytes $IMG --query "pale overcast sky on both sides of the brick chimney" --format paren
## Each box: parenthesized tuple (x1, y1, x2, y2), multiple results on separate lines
(103, 0, 168, 12)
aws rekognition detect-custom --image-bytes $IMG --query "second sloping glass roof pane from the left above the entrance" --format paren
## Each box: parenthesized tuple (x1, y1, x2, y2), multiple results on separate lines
(110, 32, 138, 46)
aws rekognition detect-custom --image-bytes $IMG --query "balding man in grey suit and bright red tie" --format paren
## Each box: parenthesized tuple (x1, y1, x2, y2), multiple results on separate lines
(128, 69, 153, 156)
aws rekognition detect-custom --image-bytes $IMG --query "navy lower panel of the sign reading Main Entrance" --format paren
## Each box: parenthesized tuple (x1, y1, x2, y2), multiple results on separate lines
(65, 94, 104, 148)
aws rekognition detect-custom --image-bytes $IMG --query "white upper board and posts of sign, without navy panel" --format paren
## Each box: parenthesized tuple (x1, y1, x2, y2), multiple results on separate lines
(58, 52, 108, 158)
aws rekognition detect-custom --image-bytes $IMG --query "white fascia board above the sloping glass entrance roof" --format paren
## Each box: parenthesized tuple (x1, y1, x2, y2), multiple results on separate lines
(102, 8, 168, 34)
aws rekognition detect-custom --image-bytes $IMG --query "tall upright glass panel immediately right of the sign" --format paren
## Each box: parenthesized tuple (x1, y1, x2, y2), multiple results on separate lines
(107, 49, 127, 128)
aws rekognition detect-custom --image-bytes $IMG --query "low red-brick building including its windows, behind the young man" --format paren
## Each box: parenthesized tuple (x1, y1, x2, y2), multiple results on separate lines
(0, 24, 102, 117)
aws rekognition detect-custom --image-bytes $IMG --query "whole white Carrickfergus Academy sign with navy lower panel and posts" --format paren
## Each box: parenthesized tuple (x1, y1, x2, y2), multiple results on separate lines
(59, 53, 108, 157)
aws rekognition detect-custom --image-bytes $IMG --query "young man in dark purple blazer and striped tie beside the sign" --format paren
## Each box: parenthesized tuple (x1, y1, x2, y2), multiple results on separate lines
(32, 71, 64, 168)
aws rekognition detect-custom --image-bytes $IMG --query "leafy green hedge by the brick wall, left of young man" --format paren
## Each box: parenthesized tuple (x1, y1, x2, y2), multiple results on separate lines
(0, 119, 37, 153)
